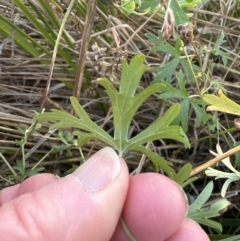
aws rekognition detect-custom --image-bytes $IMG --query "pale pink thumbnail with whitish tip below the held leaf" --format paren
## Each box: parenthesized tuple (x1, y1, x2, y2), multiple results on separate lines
(71, 147, 121, 192)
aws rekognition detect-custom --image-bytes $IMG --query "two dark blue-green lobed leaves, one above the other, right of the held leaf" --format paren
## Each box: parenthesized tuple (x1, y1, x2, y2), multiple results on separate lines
(147, 32, 210, 132)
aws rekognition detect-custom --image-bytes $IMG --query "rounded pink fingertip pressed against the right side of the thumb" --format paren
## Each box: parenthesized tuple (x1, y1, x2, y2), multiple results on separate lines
(111, 173, 187, 241)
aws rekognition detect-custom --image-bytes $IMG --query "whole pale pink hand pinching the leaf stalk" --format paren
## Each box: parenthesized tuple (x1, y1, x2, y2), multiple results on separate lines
(0, 148, 209, 241)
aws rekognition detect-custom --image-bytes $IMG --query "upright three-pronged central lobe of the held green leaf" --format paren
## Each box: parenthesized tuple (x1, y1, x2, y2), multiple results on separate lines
(98, 54, 163, 150)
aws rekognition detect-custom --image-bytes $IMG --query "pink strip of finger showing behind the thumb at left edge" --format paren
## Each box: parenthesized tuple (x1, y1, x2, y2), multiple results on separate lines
(0, 173, 58, 206)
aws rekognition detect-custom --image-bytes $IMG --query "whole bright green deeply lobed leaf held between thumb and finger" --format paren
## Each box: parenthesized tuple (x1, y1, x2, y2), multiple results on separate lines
(34, 54, 189, 173)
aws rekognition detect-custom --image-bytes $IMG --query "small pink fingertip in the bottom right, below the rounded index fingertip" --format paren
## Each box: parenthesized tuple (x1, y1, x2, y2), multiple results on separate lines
(166, 219, 210, 241)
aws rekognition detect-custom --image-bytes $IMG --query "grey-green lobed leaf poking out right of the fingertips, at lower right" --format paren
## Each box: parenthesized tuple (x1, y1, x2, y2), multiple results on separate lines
(188, 182, 230, 232)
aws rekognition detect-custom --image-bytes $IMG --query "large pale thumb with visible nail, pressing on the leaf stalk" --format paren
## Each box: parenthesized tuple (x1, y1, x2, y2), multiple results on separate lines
(0, 147, 129, 241)
